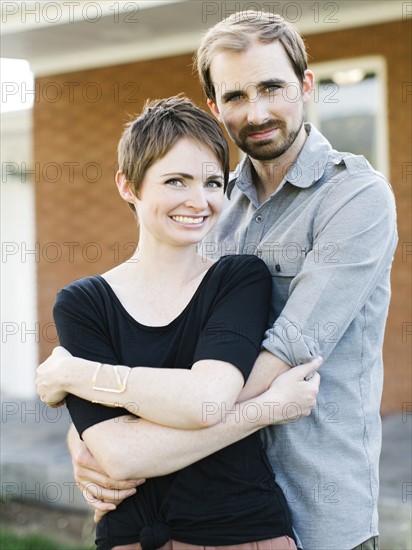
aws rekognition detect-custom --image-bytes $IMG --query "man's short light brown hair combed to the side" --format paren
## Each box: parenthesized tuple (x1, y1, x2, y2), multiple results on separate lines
(195, 10, 307, 101)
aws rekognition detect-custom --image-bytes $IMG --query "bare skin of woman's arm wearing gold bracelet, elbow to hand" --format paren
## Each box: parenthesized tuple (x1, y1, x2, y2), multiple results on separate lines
(36, 354, 243, 429)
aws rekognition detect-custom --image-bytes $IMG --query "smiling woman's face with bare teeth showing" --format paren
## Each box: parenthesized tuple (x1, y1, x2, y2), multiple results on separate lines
(134, 138, 224, 246)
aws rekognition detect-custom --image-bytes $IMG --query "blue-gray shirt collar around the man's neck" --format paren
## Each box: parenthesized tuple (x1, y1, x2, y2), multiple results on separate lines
(227, 123, 342, 200)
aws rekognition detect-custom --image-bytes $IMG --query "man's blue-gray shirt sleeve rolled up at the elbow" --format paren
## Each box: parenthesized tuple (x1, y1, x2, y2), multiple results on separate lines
(262, 171, 397, 365)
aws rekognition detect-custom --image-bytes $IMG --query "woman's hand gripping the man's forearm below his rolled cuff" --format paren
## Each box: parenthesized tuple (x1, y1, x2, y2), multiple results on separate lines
(259, 357, 323, 426)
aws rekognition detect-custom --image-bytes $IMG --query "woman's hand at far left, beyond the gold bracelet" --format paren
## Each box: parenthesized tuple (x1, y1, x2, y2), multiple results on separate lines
(36, 346, 72, 407)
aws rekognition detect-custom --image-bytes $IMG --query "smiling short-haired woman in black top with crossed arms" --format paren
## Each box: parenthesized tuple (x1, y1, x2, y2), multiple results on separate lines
(37, 97, 316, 550)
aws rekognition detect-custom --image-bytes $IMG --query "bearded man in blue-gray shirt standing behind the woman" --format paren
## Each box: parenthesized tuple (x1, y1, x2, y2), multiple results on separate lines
(67, 12, 397, 550)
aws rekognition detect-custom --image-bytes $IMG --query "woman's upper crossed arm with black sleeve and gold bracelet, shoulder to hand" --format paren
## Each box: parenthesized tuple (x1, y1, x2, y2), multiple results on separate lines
(37, 256, 271, 429)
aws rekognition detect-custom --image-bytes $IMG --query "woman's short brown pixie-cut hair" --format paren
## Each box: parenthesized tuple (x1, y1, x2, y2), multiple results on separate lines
(117, 95, 229, 215)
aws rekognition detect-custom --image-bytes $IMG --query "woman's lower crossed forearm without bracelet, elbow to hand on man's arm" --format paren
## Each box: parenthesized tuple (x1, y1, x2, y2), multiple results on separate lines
(73, 360, 321, 480)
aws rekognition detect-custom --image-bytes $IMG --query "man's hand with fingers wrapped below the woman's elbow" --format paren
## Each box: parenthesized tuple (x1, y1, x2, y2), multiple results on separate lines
(68, 426, 145, 523)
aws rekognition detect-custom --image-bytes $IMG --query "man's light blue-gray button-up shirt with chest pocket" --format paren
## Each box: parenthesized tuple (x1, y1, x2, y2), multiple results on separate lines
(202, 124, 397, 550)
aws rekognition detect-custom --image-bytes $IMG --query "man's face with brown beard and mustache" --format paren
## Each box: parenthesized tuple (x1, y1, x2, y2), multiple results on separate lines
(208, 41, 313, 161)
